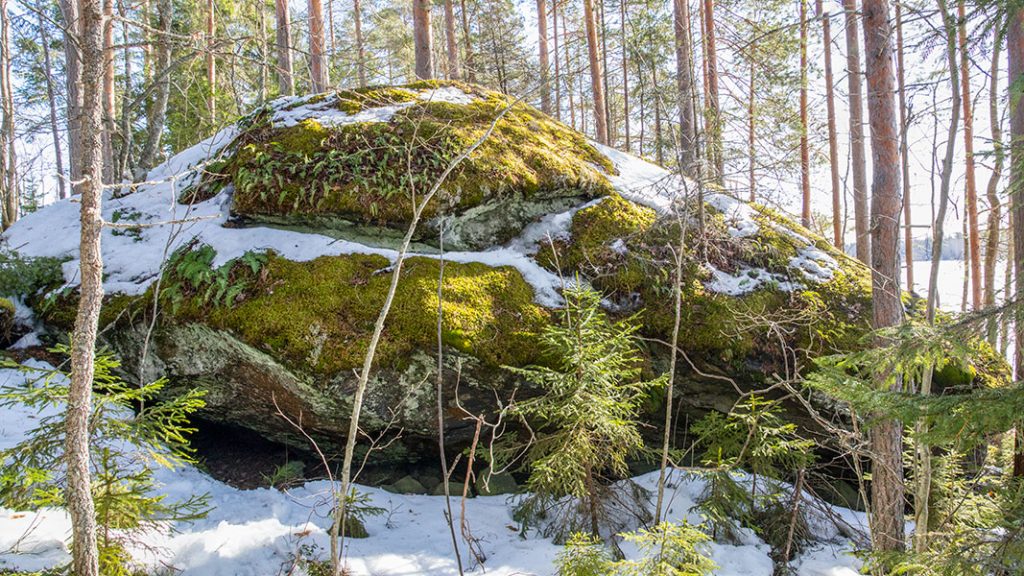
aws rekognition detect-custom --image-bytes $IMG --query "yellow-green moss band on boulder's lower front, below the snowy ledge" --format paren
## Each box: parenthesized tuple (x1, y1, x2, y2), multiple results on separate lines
(167, 248, 549, 374)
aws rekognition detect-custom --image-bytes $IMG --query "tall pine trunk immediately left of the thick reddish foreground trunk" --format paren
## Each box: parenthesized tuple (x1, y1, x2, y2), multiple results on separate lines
(843, 0, 871, 264)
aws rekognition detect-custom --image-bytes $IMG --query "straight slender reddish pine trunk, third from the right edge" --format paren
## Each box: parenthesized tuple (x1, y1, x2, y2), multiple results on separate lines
(956, 0, 981, 310)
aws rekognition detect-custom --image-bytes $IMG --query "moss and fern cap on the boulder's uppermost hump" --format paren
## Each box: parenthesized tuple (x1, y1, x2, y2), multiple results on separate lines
(219, 84, 614, 241)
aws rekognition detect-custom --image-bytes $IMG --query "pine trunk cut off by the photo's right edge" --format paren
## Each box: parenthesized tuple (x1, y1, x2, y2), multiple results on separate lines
(1007, 0, 1024, 478)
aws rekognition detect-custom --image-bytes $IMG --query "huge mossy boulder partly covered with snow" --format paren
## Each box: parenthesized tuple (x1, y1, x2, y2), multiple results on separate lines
(3, 82, 1005, 460)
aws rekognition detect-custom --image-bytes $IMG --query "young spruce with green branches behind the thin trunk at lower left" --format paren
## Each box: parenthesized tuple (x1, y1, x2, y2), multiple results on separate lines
(0, 345, 207, 576)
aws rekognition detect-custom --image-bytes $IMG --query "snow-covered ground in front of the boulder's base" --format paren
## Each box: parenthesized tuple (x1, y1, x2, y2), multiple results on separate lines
(0, 363, 866, 576)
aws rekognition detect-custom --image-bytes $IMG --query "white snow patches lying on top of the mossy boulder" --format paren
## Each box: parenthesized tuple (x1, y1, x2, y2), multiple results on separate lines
(0, 91, 837, 306)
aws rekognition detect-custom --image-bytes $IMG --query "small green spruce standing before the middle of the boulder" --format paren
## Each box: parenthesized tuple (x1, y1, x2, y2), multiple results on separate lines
(507, 287, 659, 534)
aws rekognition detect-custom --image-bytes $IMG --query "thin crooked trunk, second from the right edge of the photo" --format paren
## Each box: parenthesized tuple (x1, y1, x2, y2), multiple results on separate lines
(985, 20, 1009, 348)
